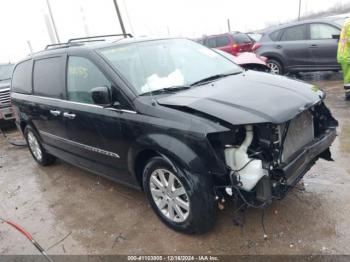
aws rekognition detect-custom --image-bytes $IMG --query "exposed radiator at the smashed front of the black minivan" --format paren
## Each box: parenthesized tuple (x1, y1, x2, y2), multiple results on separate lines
(280, 111, 314, 162)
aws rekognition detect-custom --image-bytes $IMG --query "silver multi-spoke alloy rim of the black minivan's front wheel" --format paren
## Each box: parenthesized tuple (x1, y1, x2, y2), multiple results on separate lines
(149, 169, 190, 223)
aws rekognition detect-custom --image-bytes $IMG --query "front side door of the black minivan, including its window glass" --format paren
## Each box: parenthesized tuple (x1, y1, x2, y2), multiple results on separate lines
(63, 56, 131, 183)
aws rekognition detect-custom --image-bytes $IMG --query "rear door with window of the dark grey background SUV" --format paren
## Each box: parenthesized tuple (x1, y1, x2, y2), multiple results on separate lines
(275, 24, 313, 69)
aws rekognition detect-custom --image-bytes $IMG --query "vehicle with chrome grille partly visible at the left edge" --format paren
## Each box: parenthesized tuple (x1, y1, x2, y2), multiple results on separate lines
(0, 64, 15, 121)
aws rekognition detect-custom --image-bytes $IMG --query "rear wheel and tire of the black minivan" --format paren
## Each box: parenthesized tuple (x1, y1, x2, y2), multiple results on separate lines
(23, 126, 55, 166)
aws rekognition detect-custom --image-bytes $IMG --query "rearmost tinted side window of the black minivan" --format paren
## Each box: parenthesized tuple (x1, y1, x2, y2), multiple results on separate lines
(12, 60, 32, 94)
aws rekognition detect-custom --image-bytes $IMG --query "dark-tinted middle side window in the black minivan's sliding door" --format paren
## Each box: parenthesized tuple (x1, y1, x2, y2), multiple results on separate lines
(33, 57, 64, 98)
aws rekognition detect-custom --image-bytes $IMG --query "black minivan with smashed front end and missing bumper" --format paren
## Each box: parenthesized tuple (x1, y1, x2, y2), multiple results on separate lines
(12, 38, 337, 233)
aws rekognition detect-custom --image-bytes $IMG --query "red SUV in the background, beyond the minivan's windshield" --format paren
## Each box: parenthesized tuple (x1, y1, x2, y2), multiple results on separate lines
(202, 32, 254, 55)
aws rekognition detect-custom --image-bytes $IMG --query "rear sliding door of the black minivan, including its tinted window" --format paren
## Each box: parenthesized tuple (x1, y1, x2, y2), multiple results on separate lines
(28, 54, 68, 150)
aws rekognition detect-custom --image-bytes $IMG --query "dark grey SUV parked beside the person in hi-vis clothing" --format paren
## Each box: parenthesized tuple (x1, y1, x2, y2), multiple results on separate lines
(254, 18, 341, 74)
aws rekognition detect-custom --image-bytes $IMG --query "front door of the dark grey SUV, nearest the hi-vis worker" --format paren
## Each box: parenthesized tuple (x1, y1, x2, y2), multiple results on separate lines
(308, 23, 340, 69)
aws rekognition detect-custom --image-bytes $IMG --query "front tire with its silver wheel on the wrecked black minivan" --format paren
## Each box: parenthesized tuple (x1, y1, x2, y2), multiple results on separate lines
(143, 157, 216, 234)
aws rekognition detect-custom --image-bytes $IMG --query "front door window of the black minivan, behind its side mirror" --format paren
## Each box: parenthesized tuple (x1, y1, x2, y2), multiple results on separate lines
(67, 56, 111, 104)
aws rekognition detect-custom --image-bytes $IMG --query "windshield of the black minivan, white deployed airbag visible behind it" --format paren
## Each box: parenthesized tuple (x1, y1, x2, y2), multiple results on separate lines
(99, 39, 242, 95)
